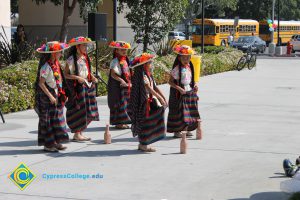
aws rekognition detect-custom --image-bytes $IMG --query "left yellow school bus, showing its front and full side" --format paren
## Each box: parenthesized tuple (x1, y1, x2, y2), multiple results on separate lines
(192, 19, 259, 46)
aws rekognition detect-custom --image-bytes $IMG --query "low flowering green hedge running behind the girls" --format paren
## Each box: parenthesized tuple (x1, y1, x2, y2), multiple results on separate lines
(0, 49, 242, 113)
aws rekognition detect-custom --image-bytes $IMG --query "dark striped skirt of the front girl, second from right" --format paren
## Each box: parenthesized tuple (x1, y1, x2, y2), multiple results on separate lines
(138, 107, 166, 145)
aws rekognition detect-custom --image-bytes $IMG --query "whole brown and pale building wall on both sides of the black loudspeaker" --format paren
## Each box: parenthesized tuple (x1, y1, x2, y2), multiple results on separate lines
(18, 0, 133, 42)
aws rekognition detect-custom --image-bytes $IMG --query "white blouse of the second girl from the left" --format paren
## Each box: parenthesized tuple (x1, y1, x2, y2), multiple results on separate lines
(67, 56, 89, 79)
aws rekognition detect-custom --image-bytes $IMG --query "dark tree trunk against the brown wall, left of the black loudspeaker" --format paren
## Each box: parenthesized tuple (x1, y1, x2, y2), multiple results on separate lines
(59, 0, 78, 42)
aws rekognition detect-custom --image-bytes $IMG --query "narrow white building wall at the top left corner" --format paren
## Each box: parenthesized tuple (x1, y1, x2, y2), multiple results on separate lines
(0, 0, 11, 42)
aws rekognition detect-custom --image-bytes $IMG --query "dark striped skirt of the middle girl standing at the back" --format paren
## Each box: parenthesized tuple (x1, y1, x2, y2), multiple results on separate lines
(110, 88, 131, 125)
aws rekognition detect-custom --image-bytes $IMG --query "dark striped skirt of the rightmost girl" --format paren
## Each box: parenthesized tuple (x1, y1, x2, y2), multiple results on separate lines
(167, 91, 200, 133)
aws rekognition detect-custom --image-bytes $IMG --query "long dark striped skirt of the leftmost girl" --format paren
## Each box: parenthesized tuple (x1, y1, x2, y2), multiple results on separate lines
(36, 87, 69, 147)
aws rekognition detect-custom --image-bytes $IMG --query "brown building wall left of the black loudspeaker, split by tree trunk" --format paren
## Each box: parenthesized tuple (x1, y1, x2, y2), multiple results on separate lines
(19, 0, 87, 42)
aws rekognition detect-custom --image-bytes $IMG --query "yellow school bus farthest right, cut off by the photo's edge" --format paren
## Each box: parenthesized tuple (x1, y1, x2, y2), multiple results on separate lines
(259, 20, 300, 44)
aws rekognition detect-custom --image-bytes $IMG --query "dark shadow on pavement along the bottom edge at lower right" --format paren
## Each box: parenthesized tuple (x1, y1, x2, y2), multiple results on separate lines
(228, 192, 290, 200)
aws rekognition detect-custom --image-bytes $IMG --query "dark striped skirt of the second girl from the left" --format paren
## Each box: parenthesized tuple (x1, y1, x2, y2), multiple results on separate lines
(67, 84, 99, 133)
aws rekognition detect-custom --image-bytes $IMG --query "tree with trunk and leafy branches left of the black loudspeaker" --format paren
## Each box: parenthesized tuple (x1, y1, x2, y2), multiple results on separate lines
(32, 0, 102, 41)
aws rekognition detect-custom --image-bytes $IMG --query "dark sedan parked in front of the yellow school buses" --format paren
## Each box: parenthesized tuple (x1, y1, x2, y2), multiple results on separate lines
(232, 36, 267, 53)
